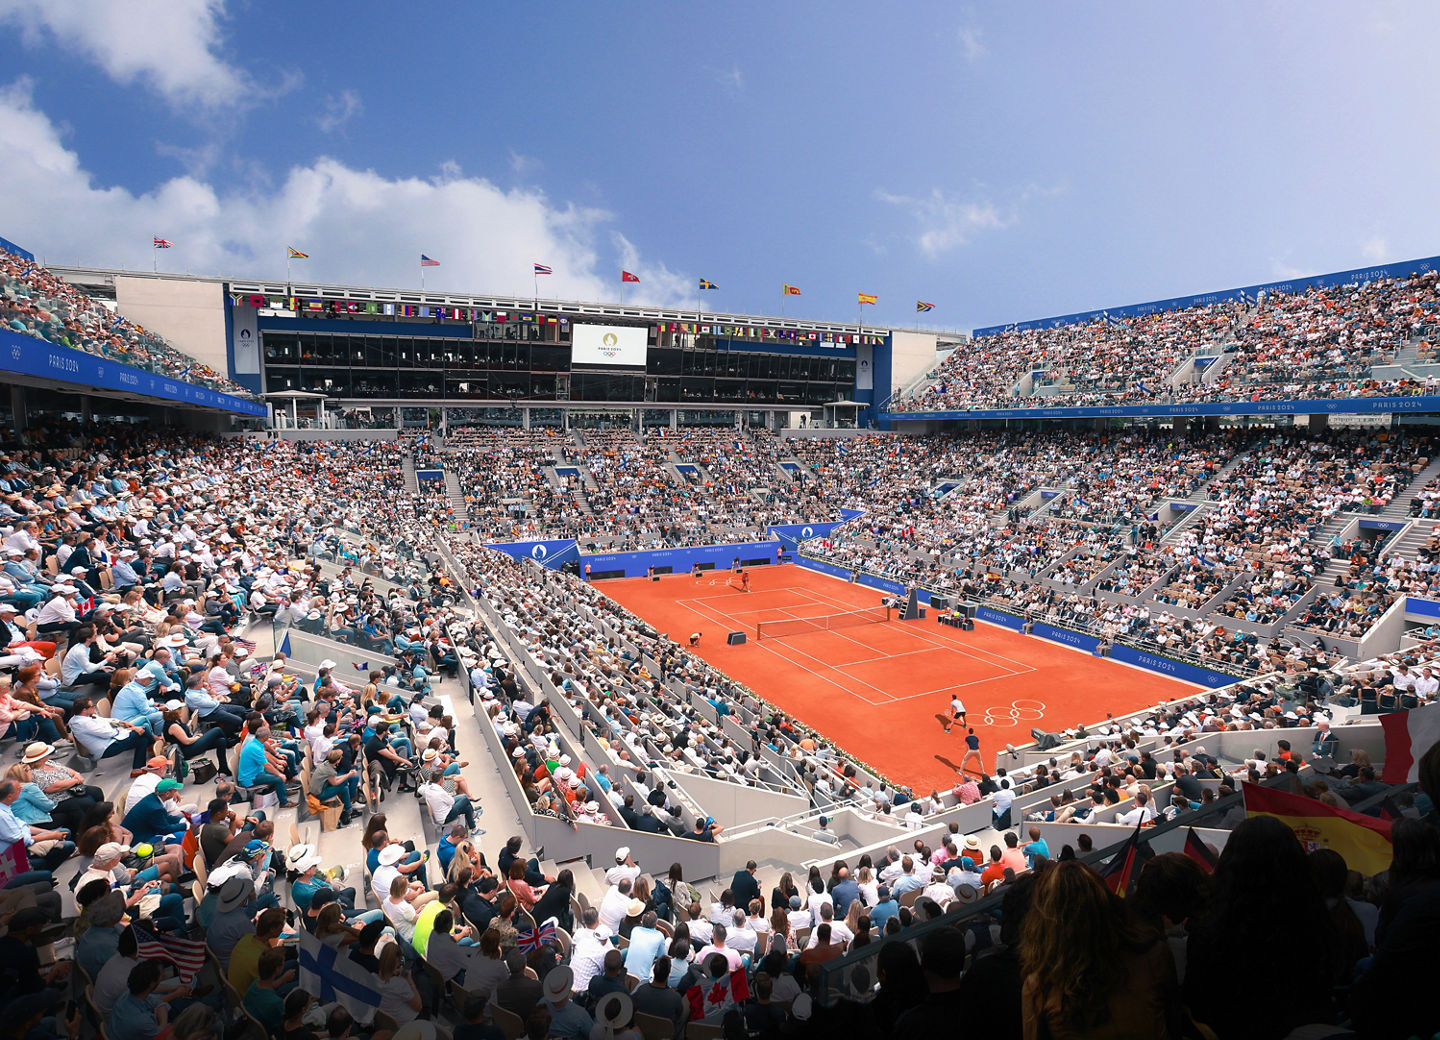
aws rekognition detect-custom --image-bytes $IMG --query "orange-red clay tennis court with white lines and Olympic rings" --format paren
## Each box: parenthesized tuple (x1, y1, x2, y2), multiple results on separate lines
(598, 565, 1195, 791)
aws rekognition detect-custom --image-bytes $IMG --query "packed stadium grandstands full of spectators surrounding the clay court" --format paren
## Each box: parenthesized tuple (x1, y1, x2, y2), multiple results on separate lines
(0, 237, 1440, 1040)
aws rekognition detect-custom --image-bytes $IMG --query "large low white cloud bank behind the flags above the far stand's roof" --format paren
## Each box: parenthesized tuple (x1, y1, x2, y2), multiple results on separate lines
(0, 82, 693, 304)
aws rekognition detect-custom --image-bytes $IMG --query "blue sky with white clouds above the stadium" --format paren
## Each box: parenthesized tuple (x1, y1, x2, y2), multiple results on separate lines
(0, 0, 1440, 328)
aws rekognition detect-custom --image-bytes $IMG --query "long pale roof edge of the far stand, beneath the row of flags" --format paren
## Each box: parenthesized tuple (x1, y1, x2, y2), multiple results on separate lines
(46, 264, 969, 340)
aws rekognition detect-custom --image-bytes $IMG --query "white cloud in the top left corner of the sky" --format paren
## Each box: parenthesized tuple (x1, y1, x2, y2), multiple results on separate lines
(0, 0, 277, 107)
